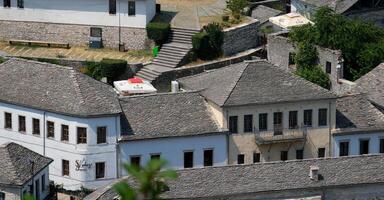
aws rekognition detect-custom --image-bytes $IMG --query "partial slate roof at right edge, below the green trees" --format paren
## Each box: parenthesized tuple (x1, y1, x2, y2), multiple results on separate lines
(355, 63, 384, 109)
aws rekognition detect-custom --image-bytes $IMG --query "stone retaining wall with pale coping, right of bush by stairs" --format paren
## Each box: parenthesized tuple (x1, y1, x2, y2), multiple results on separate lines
(222, 18, 260, 56)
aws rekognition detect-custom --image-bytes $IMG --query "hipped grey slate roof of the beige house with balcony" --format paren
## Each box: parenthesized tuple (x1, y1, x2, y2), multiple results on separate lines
(178, 60, 336, 106)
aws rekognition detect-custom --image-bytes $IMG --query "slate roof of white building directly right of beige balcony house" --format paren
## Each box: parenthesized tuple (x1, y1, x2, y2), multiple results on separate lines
(336, 94, 384, 130)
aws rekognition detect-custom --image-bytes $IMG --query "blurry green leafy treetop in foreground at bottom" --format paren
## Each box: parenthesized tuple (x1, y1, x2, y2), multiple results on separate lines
(114, 159, 177, 200)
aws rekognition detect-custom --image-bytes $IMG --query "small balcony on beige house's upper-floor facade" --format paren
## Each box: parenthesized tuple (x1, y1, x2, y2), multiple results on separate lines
(255, 126, 307, 144)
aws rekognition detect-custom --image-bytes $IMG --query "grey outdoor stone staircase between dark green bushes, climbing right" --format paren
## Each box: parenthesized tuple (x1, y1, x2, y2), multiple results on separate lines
(136, 28, 198, 82)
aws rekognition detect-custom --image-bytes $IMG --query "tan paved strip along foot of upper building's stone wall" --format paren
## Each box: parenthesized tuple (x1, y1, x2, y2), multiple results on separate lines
(0, 42, 152, 63)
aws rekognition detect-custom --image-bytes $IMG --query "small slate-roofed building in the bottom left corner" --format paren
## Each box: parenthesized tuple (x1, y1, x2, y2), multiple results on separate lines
(0, 143, 53, 200)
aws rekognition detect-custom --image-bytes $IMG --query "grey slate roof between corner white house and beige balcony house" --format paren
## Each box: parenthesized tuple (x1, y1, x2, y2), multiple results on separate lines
(120, 92, 221, 140)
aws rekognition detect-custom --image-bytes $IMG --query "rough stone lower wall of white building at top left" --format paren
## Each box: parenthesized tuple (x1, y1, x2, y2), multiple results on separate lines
(0, 20, 149, 49)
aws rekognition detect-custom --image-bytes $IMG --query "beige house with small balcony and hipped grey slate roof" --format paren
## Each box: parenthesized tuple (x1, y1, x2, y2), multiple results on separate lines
(178, 60, 336, 164)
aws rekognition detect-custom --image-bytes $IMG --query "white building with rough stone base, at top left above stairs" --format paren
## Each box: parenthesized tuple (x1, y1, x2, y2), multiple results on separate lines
(0, 0, 156, 49)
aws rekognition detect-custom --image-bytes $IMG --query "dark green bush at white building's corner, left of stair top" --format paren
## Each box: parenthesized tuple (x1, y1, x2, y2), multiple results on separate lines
(147, 22, 171, 45)
